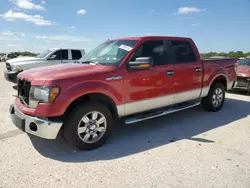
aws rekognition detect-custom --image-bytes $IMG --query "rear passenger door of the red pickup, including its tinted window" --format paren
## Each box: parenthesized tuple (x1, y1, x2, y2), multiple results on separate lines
(168, 40, 202, 104)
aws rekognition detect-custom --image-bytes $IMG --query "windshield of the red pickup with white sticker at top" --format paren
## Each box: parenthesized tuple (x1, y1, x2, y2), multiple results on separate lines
(79, 40, 138, 66)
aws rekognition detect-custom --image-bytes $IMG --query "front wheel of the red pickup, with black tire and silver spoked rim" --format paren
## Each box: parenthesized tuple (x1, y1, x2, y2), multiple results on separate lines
(63, 102, 113, 150)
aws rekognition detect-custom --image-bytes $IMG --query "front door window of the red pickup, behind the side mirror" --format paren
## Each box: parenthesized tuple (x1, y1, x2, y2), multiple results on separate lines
(131, 40, 168, 66)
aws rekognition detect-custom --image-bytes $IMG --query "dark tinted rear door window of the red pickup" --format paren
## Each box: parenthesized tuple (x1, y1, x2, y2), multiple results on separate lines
(171, 41, 196, 63)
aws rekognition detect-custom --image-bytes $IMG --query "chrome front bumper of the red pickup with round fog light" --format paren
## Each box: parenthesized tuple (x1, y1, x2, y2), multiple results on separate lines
(9, 104, 63, 139)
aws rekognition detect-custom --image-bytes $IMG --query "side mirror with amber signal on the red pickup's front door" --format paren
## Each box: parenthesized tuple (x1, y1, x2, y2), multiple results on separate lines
(128, 57, 153, 70)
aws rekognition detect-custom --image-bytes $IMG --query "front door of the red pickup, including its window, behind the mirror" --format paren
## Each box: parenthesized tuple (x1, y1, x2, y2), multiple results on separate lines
(124, 40, 173, 115)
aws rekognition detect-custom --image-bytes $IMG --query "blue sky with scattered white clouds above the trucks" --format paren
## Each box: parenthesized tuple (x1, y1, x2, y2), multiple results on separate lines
(0, 0, 250, 53)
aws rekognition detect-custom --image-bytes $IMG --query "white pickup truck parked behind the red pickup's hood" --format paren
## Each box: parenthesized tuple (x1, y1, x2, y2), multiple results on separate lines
(4, 48, 85, 83)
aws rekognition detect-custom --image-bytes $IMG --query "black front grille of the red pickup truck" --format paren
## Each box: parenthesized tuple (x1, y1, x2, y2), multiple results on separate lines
(17, 79, 31, 105)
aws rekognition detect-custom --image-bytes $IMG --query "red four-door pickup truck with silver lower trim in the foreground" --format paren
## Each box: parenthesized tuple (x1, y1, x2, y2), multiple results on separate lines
(10, 36, 236, 150)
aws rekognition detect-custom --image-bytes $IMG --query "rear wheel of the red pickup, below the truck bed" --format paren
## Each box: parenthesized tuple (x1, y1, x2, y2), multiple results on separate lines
(201, 82, 225, 112)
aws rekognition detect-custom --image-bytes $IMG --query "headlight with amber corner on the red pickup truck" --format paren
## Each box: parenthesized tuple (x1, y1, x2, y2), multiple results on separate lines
(29, 86, 60, 108)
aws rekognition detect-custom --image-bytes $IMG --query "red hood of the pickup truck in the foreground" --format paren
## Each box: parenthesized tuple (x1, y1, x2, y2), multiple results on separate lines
(18, 63, 115, 83)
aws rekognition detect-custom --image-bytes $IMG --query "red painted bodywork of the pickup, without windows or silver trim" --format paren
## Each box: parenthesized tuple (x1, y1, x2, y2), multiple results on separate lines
(15, 36, 236, 117)
